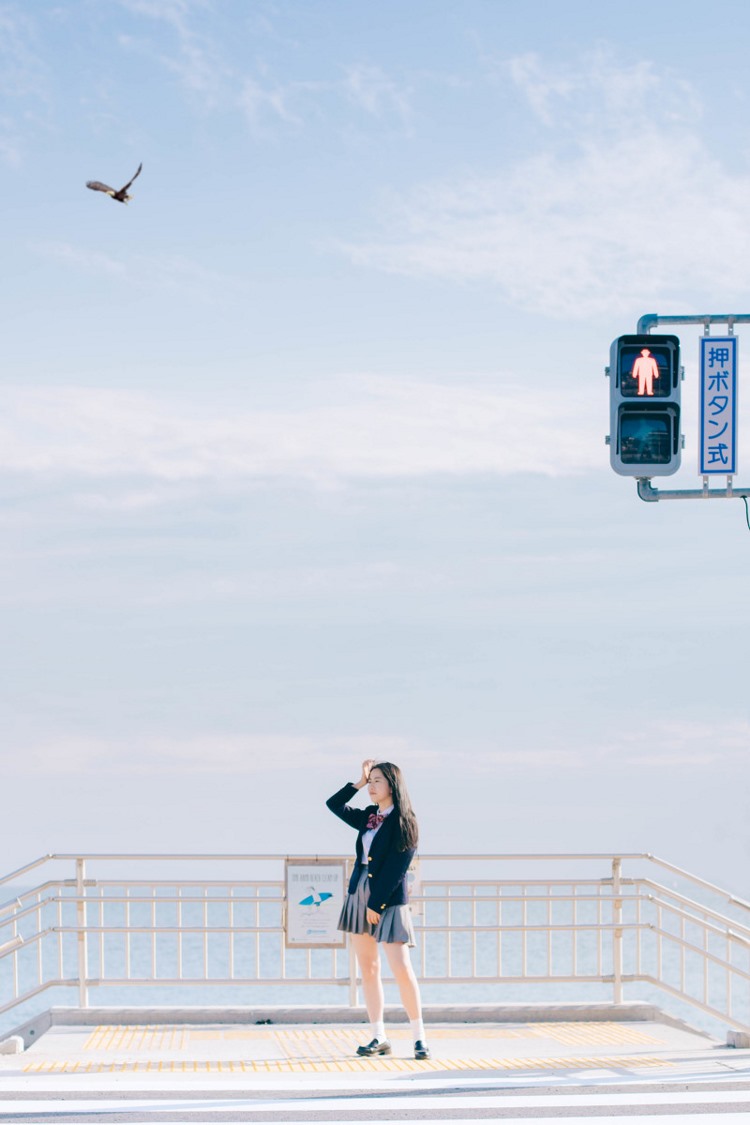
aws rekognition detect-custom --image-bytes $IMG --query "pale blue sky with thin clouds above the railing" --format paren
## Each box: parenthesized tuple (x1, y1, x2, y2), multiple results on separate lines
(0, 0, 750, 896)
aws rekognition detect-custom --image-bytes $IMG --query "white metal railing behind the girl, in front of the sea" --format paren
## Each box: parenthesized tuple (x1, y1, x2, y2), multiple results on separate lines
(0, 854, 750, 1031)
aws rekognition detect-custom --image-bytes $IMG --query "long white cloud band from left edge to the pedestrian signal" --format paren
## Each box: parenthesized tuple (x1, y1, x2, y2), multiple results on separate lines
(0, 378, 606, 484)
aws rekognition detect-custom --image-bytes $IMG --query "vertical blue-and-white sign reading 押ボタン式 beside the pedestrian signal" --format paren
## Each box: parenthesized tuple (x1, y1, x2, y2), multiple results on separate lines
(698, 336, 737, 476)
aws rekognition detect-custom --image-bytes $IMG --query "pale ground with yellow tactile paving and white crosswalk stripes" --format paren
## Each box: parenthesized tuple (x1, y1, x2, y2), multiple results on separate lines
(0, 1006, 750, 1125)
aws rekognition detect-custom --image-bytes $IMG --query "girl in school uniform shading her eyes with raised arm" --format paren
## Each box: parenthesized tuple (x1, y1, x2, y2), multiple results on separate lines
(326, 758, 430, 1059)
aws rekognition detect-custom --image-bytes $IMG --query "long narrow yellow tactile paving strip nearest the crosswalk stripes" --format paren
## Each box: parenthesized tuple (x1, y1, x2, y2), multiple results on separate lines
(24, 1055, 674, 1074)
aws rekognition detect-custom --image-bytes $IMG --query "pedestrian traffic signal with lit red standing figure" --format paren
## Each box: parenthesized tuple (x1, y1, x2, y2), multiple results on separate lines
(608, 335, 683, 477)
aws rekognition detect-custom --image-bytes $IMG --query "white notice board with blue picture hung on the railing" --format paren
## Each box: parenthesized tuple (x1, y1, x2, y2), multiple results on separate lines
(284, 860, 346, 948)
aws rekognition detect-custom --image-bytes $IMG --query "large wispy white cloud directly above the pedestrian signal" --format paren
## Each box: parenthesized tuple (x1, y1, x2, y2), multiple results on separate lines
(342, 55, 750, 318)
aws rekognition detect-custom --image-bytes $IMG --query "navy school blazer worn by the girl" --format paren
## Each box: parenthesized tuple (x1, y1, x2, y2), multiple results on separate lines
(326, 782, 416, 914)
